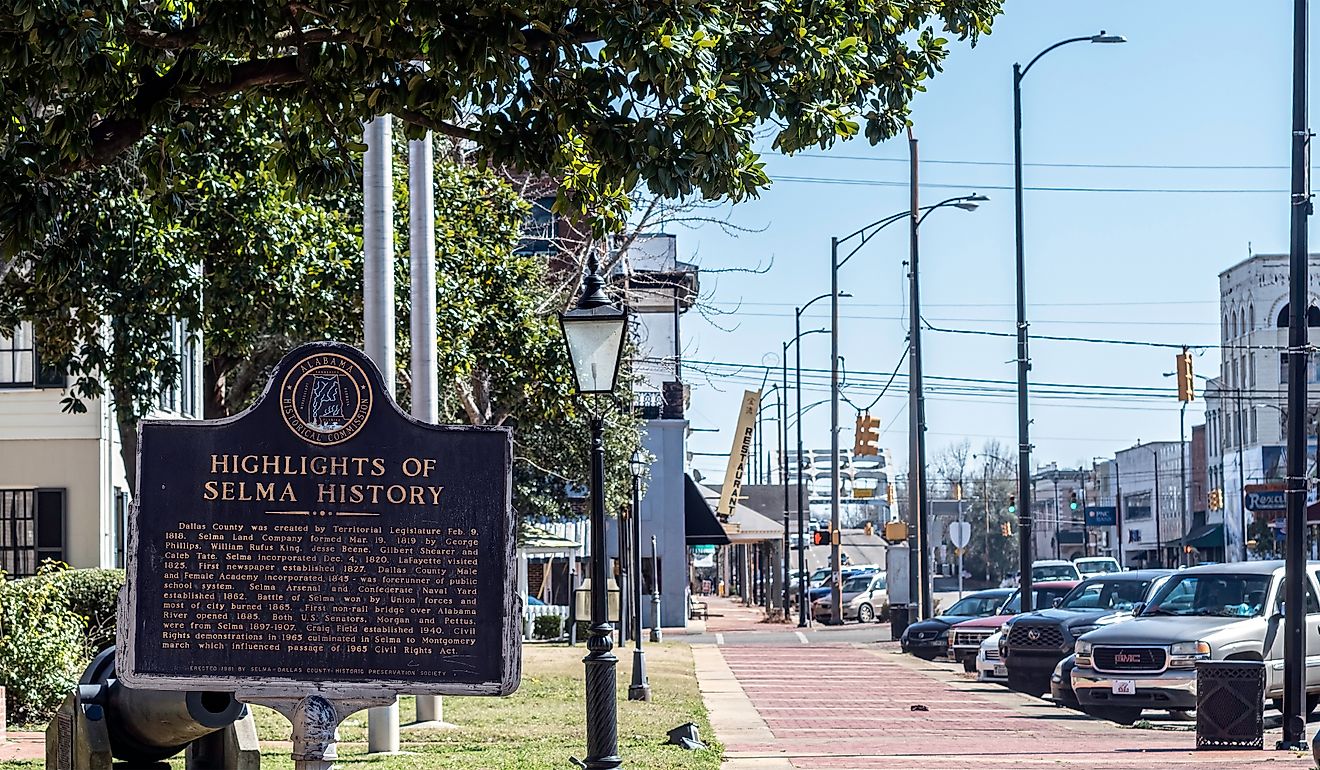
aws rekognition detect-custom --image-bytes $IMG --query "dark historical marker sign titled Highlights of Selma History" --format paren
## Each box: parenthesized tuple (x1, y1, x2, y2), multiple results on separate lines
(119, 343, 521, 695)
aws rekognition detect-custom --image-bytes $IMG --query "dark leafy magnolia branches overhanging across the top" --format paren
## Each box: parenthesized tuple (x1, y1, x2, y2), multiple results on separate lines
(0, 0, 1003, 266)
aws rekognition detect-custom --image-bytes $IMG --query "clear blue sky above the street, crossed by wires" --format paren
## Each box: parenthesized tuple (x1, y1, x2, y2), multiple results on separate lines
(673, 0, 1304, 481)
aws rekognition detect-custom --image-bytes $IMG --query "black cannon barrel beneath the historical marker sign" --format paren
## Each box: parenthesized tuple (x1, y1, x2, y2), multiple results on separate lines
(81, 647, 247, 762)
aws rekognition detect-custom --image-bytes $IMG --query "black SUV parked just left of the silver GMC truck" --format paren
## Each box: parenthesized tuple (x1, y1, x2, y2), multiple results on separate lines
(999, 569, 1173, 695)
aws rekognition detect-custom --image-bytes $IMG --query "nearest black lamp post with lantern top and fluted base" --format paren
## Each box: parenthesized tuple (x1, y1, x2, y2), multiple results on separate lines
(560, 254, 628, 770)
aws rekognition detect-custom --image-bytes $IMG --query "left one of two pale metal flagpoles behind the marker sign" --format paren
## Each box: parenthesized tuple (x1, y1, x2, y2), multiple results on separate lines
(362, 115, 399, 753)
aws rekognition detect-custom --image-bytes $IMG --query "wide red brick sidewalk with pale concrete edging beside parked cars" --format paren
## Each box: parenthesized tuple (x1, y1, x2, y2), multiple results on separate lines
(694, 645, 1315, 770)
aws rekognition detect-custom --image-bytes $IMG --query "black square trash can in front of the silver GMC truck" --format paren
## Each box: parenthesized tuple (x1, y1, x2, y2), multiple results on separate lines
(1196, 660, 1265, 749)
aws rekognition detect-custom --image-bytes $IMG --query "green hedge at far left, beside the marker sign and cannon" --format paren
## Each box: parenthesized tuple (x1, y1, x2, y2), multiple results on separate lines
(0, 563, 124, 724)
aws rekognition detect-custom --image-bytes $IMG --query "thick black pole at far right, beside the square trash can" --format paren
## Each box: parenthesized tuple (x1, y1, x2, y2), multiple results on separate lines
(1277, 0, 1311, 749)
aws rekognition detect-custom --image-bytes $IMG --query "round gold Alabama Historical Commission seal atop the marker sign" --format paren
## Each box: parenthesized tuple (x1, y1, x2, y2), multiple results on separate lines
(280, 353, 371, 446)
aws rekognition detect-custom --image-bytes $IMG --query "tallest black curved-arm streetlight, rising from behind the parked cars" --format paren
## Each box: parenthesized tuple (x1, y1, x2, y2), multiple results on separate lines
(1012, 30, 1127, 613)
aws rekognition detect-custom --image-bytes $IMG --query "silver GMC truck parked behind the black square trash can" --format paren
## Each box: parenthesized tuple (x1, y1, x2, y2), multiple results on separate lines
(1072, 561, 1320, 724)
